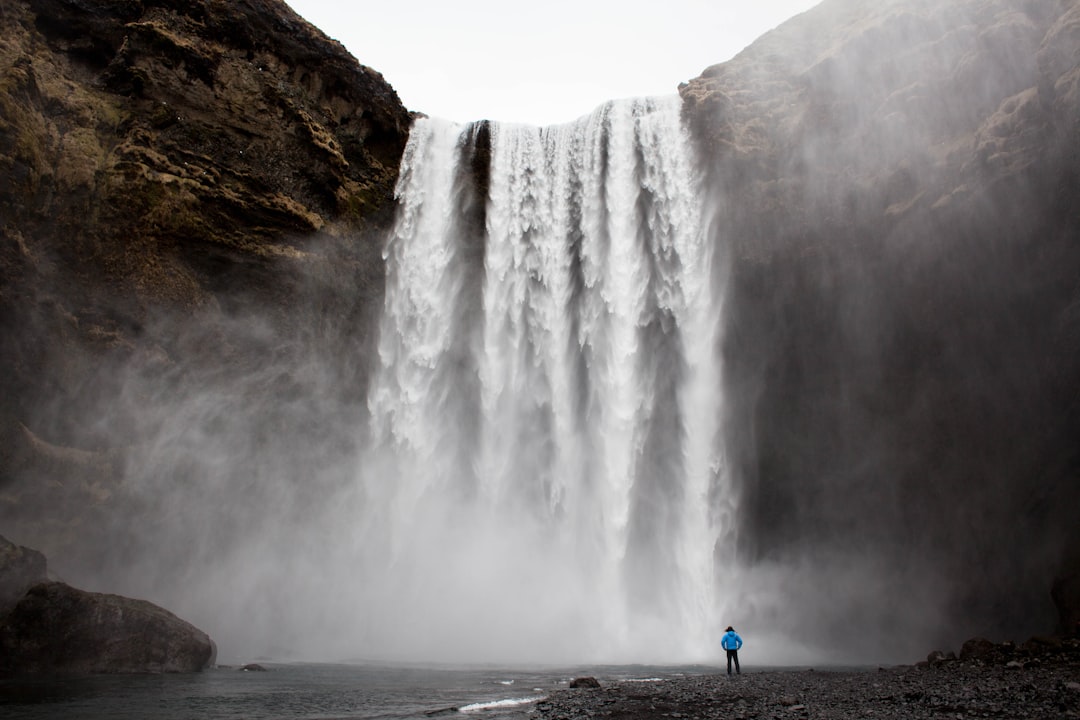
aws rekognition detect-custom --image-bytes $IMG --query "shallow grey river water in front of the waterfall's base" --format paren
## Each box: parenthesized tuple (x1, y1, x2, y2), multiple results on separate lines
(0, 663, 716, 720)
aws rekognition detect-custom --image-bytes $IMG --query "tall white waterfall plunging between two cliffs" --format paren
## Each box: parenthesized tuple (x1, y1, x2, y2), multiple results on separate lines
(356, 97, 731, 662)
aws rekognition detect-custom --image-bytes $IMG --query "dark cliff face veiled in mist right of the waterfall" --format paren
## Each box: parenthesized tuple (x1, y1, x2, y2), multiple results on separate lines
(680, 0, 1080, 643)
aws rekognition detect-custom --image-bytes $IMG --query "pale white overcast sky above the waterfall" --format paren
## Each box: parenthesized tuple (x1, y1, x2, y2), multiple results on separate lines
(286, 0, 820, 125)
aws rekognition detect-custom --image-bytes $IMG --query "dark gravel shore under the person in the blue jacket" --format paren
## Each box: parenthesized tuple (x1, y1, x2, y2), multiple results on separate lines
(536, 641, 1080, 720)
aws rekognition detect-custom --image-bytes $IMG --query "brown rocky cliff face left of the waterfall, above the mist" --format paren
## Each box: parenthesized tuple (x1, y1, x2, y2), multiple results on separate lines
(0, 0, 410, 554)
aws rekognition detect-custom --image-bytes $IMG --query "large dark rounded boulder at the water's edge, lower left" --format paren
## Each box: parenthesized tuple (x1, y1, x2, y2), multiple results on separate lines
(0, 582, 216, 675)
